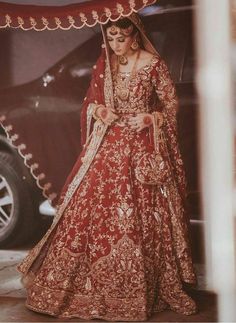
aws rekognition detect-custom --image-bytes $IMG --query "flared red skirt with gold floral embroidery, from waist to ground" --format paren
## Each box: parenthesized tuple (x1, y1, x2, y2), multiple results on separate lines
(21, 125, 194, 321)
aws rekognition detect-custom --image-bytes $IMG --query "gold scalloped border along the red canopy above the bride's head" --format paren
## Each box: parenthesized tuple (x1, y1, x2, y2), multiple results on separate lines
(0, 0, 157, 31)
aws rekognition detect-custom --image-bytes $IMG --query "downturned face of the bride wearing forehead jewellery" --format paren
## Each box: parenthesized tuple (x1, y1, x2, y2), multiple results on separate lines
(106, 25, 133, 56)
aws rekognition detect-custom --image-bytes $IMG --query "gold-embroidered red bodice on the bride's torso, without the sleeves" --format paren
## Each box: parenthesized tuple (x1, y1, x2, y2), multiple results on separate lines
(113, 56, 158, 114)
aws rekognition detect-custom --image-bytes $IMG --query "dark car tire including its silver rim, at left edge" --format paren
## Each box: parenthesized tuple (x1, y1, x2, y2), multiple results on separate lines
(0, 152, 37, 248)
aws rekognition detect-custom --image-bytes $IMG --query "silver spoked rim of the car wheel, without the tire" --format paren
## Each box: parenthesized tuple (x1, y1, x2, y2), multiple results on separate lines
(0, 175, 14, 235)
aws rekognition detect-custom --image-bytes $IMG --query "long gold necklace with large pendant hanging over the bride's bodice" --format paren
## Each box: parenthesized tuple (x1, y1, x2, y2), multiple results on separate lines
(116, 50, 140, 101)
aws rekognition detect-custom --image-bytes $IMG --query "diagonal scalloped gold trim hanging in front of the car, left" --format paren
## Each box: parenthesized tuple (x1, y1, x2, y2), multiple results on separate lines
(0, 115, 57, 202)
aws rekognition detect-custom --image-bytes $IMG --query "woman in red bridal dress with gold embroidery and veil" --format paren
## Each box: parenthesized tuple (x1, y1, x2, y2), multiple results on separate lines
(18, 14, 196, 321)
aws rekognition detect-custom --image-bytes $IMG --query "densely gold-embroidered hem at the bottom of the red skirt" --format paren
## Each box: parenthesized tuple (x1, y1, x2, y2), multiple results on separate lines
(26, 235, 196, 321)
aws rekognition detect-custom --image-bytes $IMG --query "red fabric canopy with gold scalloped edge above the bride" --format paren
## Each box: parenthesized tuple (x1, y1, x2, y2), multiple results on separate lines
(0, 0, 156, 31)
